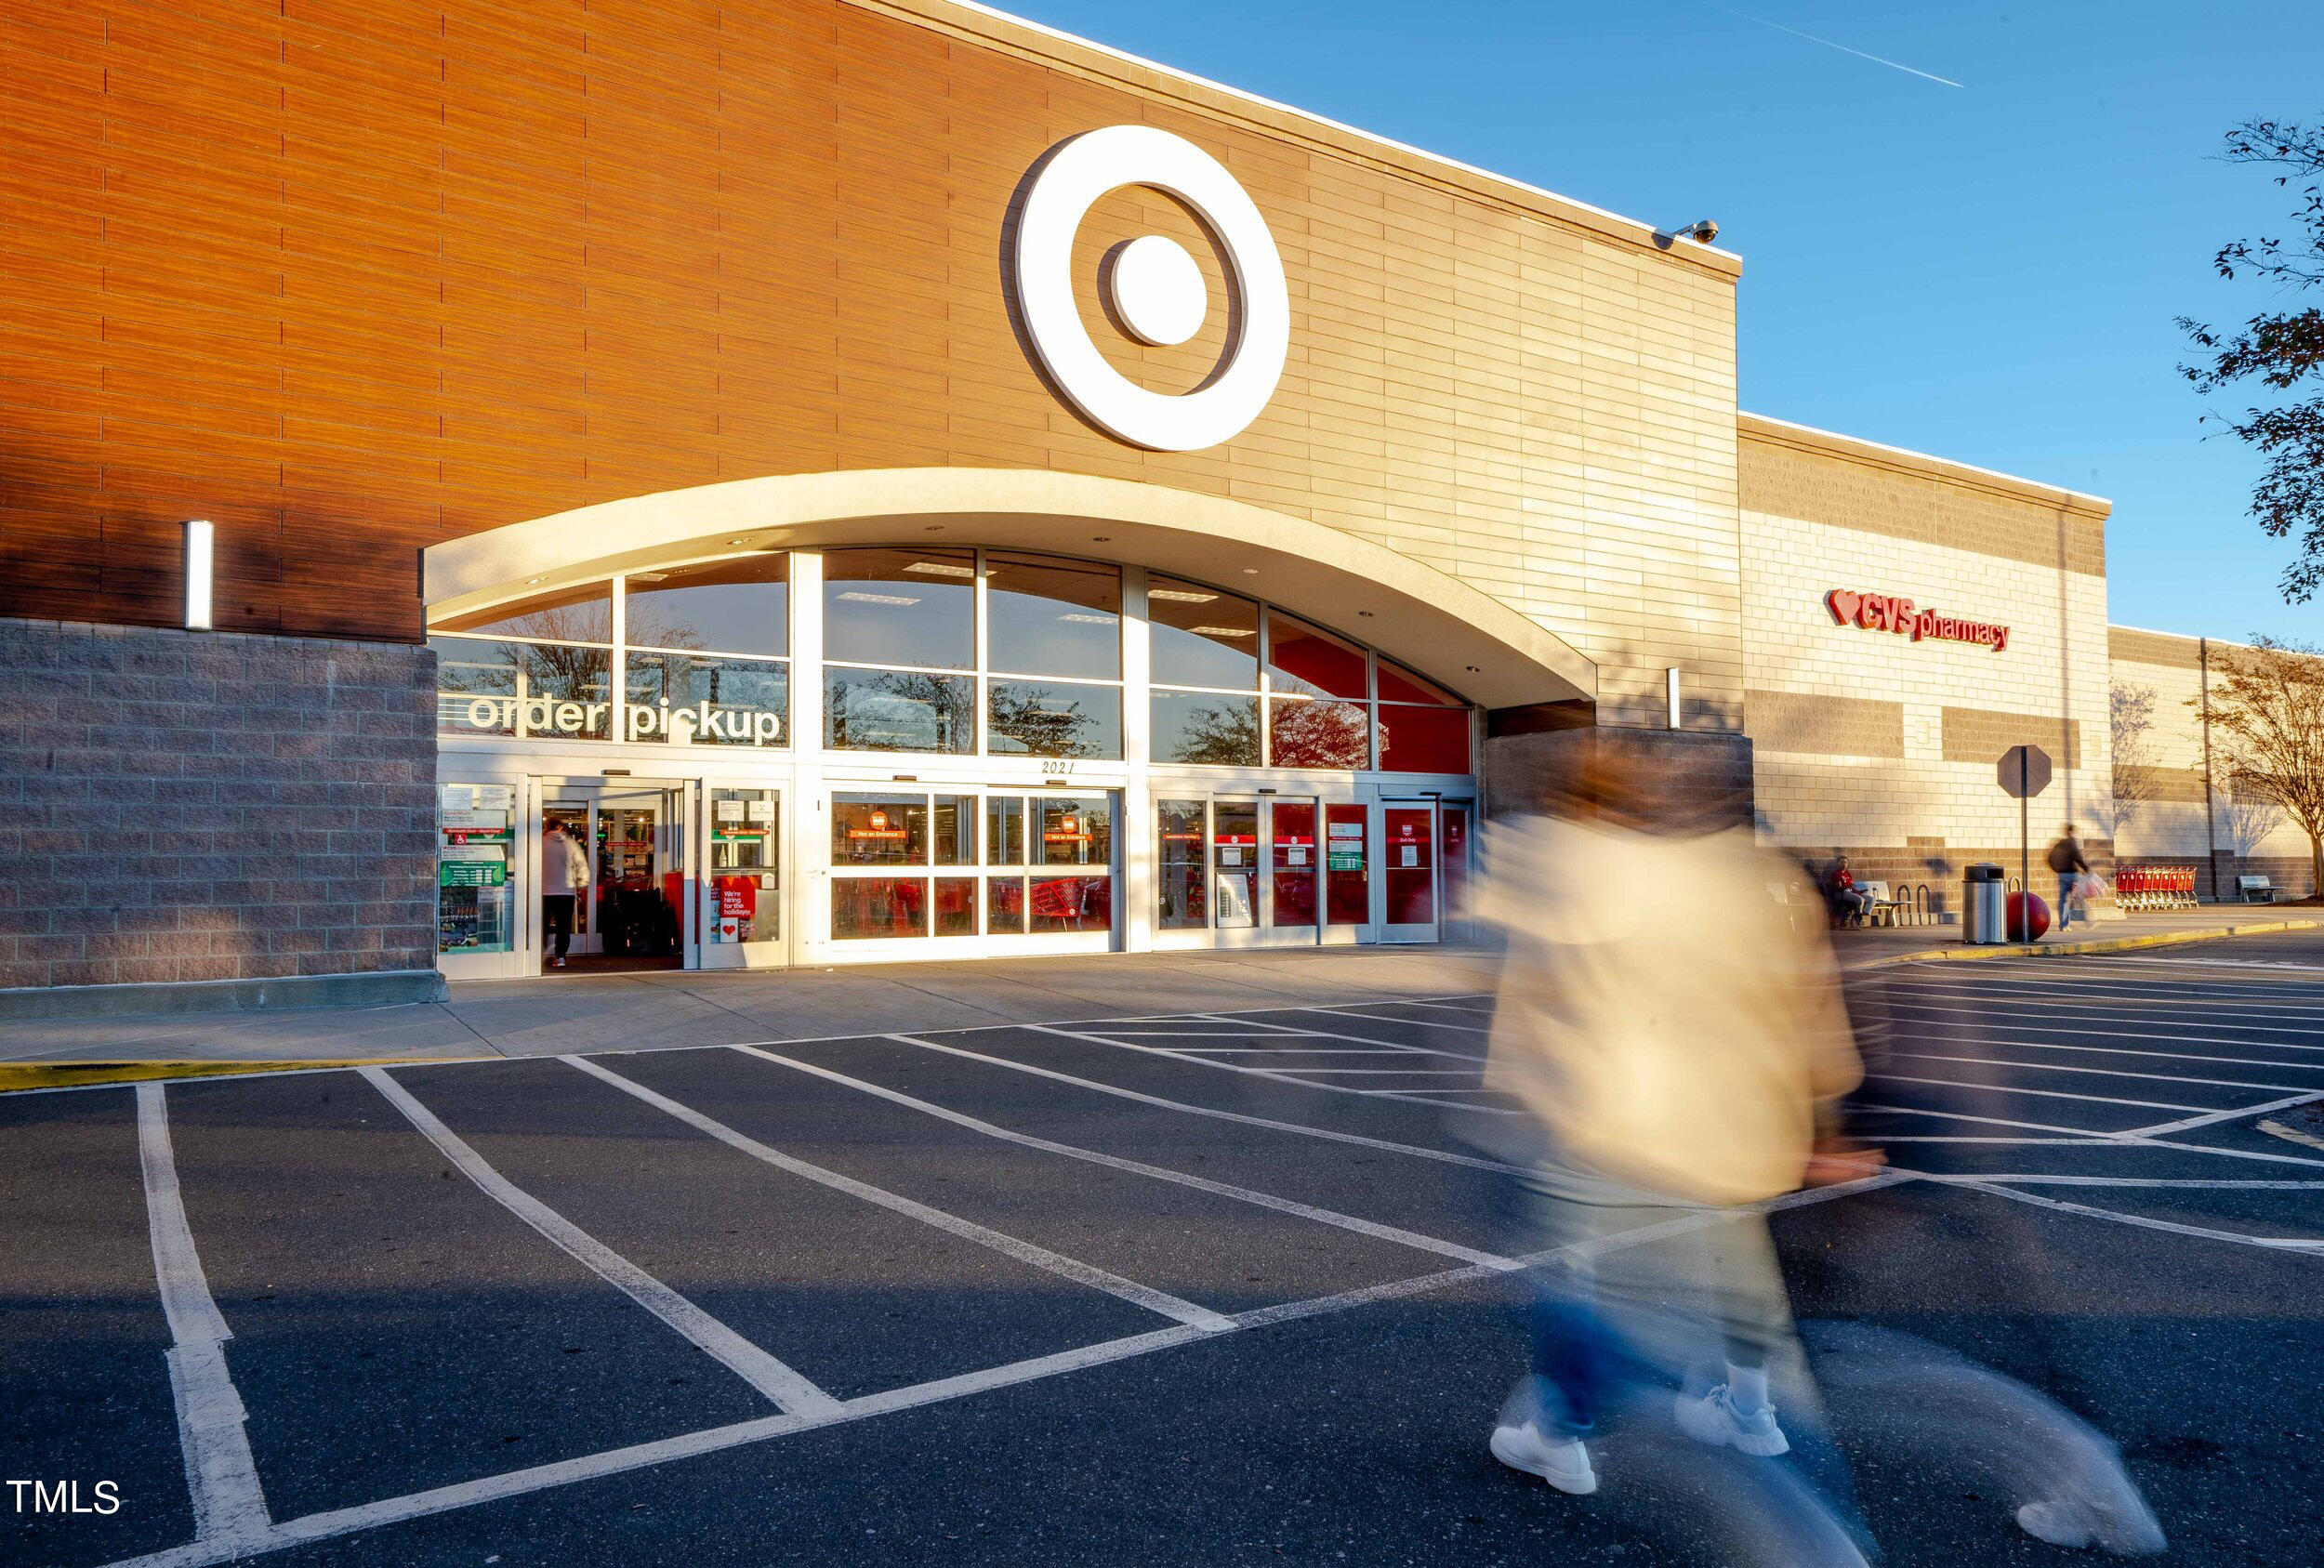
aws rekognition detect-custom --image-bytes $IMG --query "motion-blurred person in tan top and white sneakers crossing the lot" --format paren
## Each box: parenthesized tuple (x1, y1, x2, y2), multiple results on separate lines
(1469, 750, 1859, 1561)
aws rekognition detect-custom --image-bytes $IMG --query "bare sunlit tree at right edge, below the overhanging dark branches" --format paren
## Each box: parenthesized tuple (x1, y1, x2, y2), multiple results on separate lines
(2189, 637, 2324, 892)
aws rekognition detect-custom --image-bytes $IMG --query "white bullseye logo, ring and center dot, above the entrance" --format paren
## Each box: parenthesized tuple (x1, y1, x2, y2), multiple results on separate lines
(1013, 125, 1292, 453)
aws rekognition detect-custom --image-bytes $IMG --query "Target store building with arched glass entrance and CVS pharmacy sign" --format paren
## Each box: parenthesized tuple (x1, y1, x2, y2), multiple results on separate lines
(0, 0, 2108, 1010)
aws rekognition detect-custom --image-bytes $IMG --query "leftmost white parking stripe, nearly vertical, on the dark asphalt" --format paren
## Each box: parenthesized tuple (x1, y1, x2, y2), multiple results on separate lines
(138, 1083, 270, 1545)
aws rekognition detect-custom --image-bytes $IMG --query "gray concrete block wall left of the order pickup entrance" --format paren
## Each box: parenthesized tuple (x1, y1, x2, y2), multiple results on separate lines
(0, 620, 437, 987)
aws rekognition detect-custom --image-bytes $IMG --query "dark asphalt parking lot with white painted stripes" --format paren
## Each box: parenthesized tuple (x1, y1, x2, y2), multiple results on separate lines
(0, 936, 2324, 1566)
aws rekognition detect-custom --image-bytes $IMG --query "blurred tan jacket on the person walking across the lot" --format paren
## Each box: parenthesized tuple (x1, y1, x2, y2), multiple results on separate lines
(1476, 818, 1862, 1206)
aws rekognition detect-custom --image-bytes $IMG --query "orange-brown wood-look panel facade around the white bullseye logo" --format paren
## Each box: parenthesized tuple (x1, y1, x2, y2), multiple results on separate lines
(0, 0, 1734, 662)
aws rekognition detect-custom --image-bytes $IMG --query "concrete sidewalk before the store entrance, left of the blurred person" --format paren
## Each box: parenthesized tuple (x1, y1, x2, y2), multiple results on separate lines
(0, 945, 1499, 1064)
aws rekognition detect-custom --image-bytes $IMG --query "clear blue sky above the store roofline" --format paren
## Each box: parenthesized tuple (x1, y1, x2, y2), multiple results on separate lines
(1002, 0, 2324, 641)
